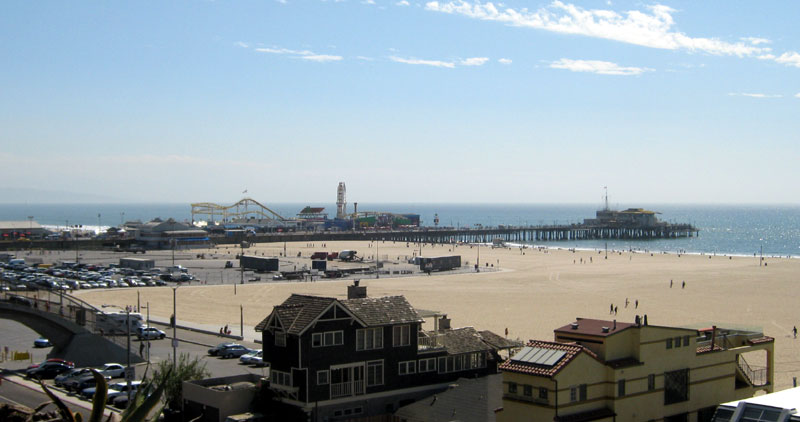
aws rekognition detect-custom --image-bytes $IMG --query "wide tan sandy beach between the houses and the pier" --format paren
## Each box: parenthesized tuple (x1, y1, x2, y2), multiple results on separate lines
(76, 242, 800, 391)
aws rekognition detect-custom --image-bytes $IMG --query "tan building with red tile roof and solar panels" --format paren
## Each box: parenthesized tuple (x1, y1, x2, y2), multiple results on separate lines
(497, 317, 774, 422)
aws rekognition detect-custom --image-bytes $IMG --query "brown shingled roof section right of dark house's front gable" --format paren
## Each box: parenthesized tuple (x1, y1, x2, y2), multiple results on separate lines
(341, 296, 425, 326)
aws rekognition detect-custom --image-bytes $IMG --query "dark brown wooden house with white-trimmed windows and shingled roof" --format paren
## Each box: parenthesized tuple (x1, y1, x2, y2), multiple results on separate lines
(256, 285, 511, 421)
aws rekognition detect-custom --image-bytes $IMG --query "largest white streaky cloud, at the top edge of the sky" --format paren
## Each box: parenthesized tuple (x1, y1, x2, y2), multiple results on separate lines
(425, 0, 769, 57)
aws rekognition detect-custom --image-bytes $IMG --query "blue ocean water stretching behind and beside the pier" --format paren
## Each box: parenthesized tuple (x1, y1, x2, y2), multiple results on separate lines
(0, 202, 800, 257)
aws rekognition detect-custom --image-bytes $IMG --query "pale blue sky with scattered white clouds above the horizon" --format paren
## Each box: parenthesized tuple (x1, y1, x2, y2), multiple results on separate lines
(0, 0, 800, 204)
